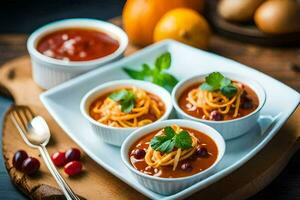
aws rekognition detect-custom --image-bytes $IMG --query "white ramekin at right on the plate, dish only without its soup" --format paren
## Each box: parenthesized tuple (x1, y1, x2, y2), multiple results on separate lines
(172, 72, 266, 139)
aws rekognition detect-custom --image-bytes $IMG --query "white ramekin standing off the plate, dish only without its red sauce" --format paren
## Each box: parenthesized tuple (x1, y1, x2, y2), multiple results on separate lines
(27, 19, 128, 89)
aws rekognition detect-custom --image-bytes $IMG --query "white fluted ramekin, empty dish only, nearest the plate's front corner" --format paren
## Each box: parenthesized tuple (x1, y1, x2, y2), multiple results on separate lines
(121, 119, 225, 195)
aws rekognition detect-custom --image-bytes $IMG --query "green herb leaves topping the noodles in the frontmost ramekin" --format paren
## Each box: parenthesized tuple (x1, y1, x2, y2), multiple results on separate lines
(150, 126, 192, 153)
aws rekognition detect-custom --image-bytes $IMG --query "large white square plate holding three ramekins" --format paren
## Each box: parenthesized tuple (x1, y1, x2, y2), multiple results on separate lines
(41, 41, 300, 199)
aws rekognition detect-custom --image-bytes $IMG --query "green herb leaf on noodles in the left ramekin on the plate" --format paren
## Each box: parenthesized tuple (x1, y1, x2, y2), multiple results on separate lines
(109, 89, 135, 113)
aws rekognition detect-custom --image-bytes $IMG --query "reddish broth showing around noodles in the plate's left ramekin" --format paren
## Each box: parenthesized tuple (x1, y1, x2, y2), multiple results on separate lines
(89, 92, 165, 122)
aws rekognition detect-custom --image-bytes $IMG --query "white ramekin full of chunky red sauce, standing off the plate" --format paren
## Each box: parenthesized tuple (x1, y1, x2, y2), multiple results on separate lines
(27, 19, 128, 89)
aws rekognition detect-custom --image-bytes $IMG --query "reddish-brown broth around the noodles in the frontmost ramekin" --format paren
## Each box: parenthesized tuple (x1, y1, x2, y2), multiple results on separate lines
(128, 127, 218, 178)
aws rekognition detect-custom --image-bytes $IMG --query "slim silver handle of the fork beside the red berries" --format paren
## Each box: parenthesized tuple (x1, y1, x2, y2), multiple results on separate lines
(39, 145, 80, 200)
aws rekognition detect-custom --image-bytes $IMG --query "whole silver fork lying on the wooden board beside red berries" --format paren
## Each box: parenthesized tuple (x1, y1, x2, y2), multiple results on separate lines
(9, 105, 80, 200)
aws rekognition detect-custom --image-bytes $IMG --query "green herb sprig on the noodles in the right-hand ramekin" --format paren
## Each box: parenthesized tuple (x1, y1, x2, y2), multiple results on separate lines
(200, 72, 237, 98)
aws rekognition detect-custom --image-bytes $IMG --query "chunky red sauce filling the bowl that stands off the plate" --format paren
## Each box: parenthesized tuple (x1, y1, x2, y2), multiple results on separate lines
(37, 28, 119, 61)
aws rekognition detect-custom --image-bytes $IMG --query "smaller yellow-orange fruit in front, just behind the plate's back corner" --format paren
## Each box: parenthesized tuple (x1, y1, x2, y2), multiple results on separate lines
(154, 8, 211, 49)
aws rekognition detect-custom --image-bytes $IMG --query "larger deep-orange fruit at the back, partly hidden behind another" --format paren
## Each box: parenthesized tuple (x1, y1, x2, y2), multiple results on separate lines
(122, 0, 204, 46)
